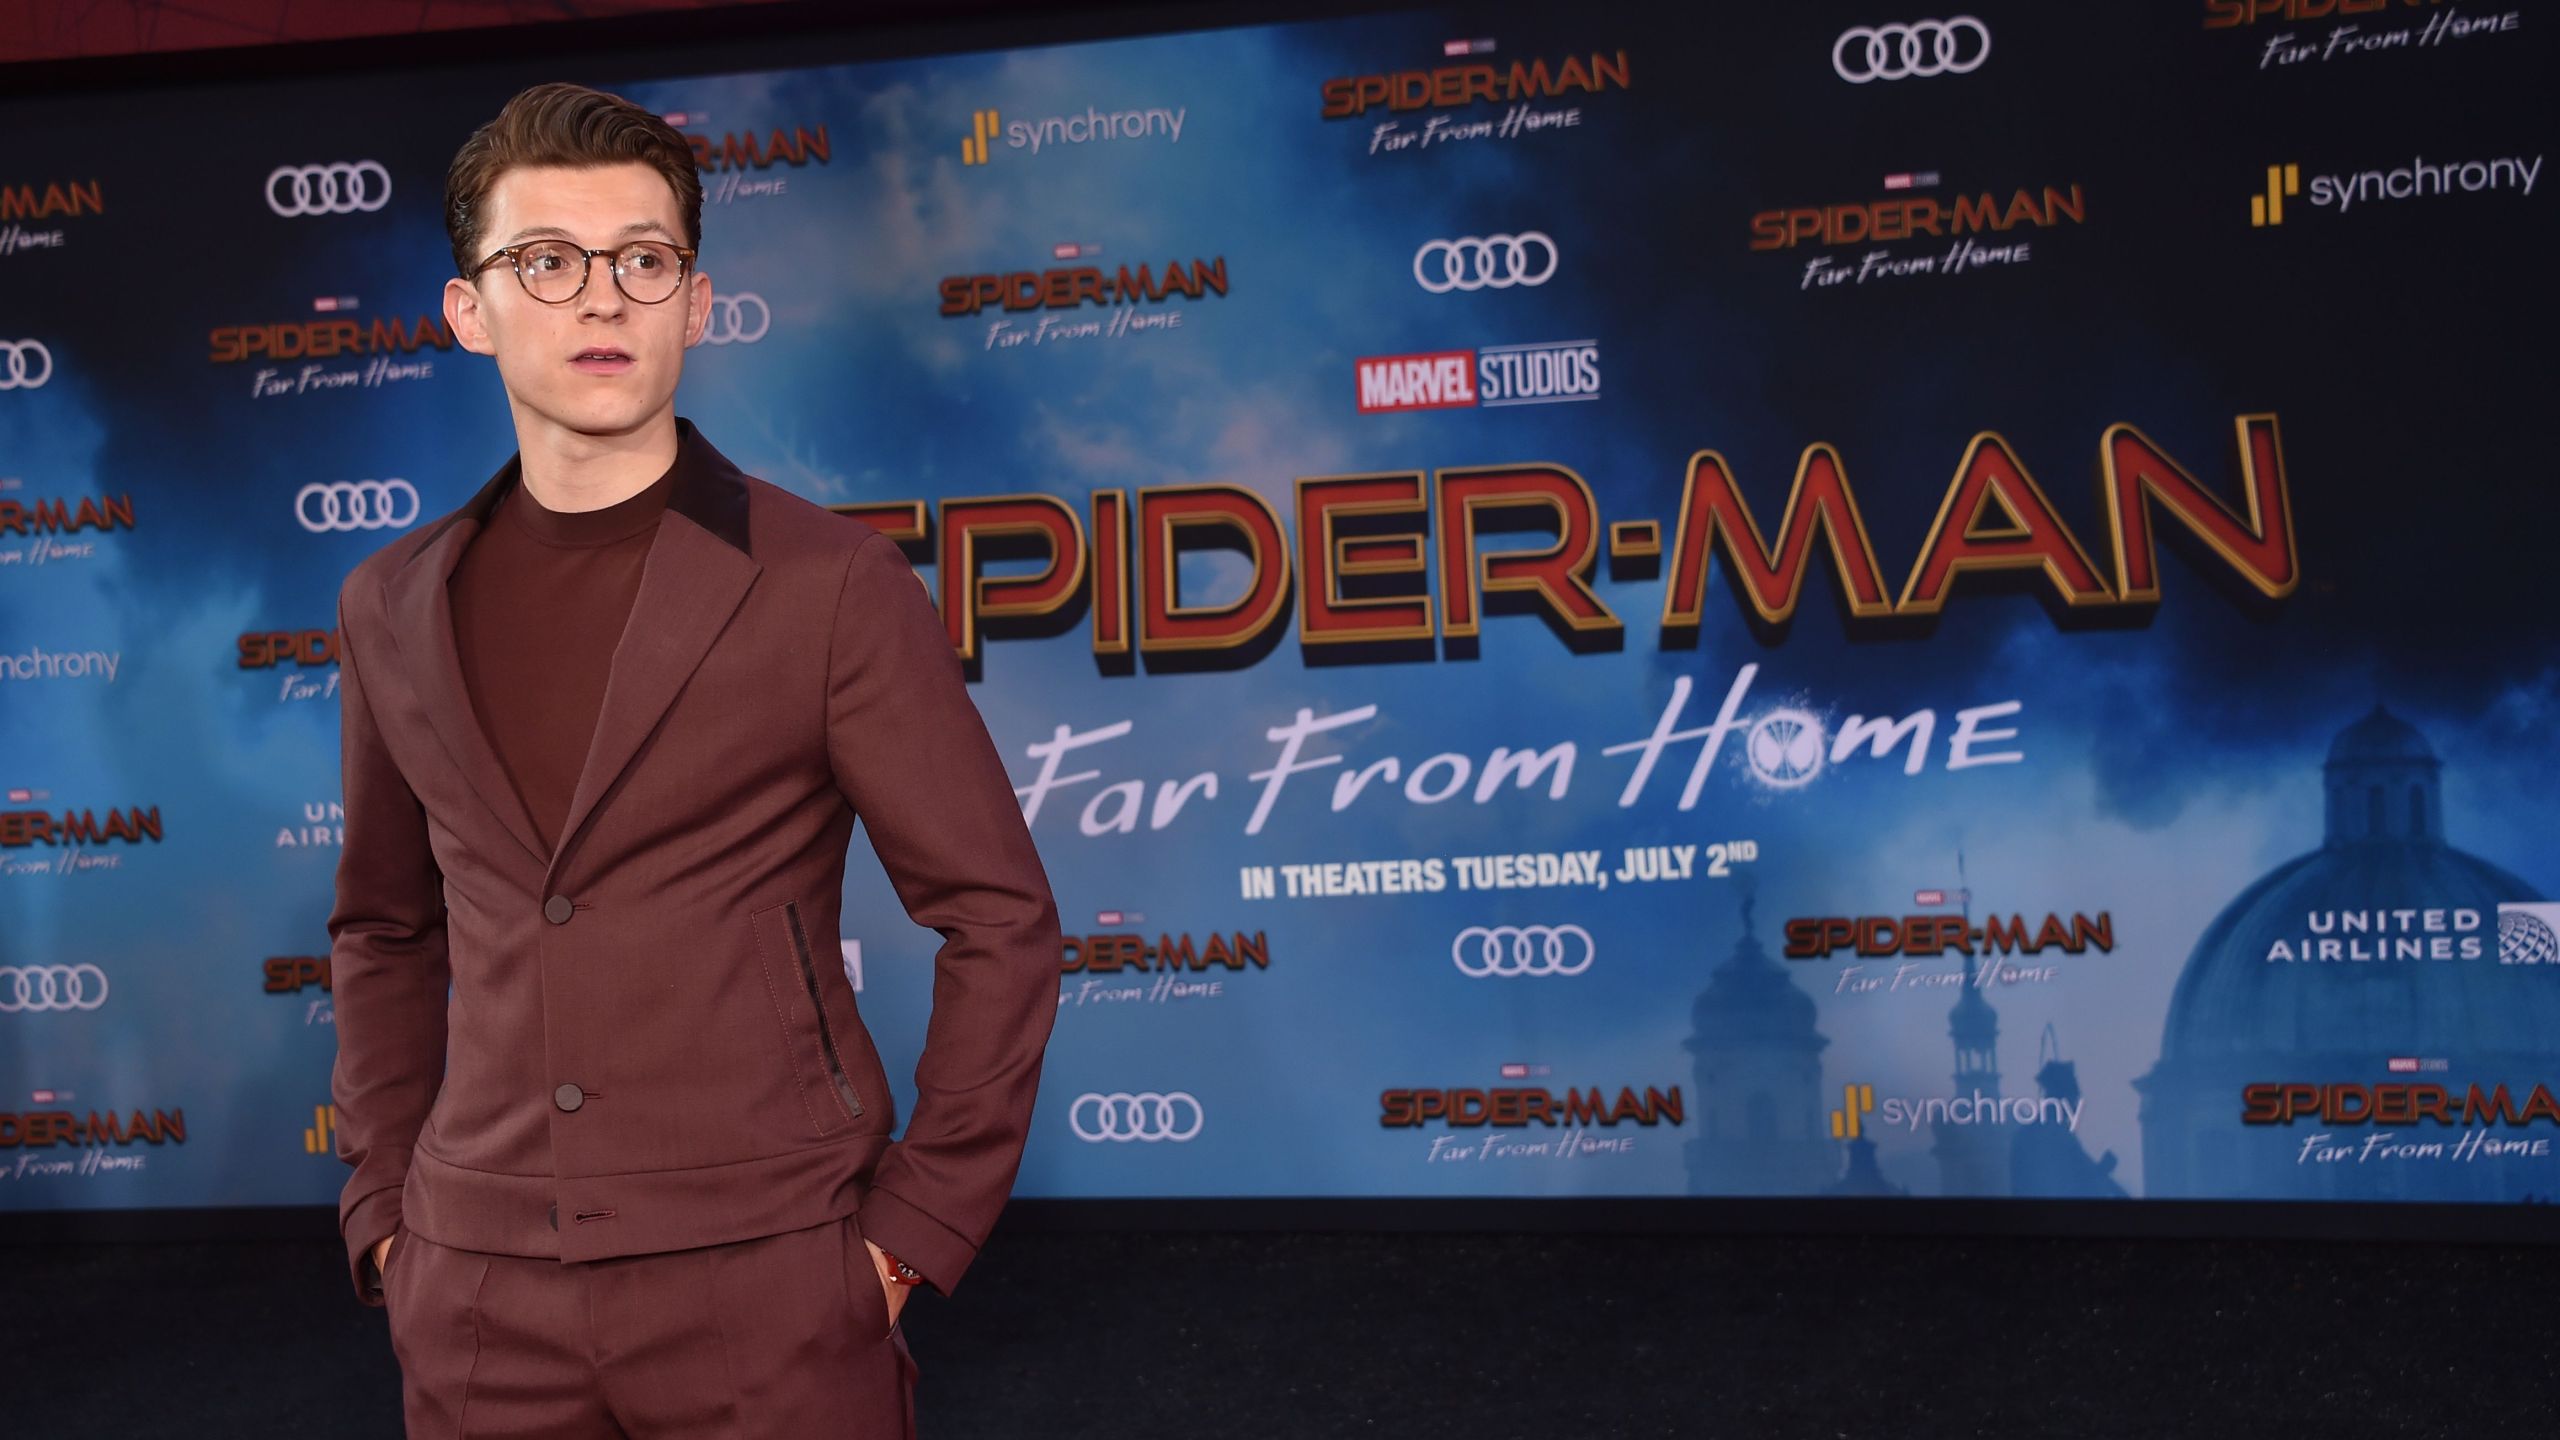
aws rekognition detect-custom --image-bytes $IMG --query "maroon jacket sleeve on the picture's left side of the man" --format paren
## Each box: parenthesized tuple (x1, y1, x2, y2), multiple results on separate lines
(328, 577, 451, 1304)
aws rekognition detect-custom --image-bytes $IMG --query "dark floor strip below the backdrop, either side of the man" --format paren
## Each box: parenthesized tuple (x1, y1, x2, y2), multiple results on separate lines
(0, 1232, 2560, 1440)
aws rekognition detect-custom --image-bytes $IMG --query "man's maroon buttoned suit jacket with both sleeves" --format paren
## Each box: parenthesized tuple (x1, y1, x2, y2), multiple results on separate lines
(328, 420, 1060, 1304)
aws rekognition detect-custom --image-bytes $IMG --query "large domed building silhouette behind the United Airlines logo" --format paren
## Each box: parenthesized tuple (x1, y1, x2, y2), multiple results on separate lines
(2135, 705, 2560, 1199)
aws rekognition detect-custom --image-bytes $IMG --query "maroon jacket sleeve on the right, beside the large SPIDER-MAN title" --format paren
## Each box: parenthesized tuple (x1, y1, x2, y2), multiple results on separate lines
(827, 533, 1060, 1294)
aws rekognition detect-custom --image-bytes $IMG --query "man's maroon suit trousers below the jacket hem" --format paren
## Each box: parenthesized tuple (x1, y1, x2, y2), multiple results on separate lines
(381, 1215, 916, 1440)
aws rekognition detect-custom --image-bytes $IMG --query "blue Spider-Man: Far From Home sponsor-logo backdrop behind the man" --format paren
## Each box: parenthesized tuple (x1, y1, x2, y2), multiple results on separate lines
(0, 0, 2560, 1209)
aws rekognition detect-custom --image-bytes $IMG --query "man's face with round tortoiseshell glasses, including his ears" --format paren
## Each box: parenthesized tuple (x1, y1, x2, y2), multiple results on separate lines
(445, 161, 712, 436)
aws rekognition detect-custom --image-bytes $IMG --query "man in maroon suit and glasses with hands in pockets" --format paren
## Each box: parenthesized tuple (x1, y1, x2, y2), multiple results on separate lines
(328, 85, 1060, 1440)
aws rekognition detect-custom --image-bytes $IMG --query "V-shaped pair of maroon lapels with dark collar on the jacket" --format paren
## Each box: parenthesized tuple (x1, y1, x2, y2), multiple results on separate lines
(384, 418, 763, 881)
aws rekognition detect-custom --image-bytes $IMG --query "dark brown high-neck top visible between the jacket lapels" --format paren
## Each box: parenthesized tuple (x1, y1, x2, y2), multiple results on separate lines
(445, 430, 684, 846)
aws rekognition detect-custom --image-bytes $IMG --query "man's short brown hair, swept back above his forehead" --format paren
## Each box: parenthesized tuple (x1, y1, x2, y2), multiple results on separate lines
(445, 79, 701, 279)
